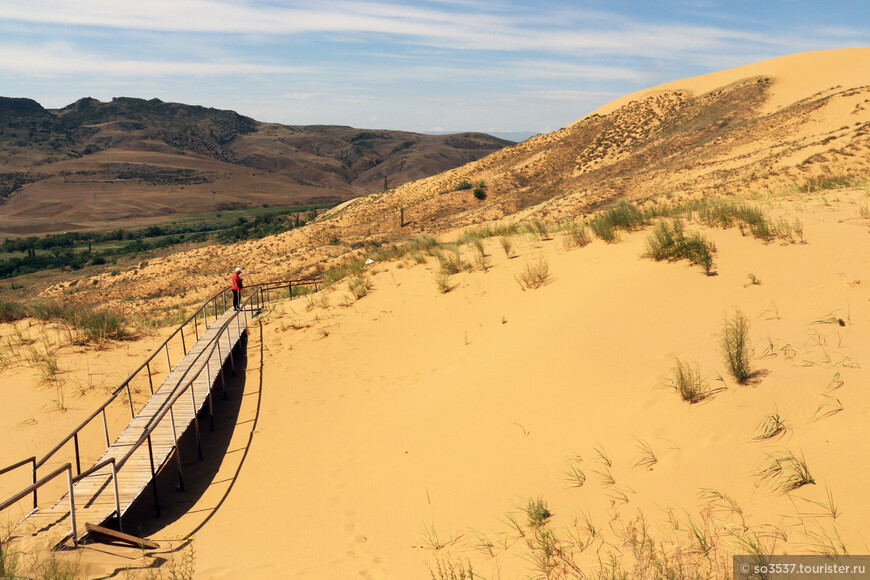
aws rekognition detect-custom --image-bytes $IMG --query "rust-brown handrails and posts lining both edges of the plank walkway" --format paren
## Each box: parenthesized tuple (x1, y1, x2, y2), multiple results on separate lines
(0, 278, 320, 544)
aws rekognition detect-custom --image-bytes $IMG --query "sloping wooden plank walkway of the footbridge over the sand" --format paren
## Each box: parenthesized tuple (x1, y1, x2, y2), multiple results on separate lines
(19, 307, 255, 543)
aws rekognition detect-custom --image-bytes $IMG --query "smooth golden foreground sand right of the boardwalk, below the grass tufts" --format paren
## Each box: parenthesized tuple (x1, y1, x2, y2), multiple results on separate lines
(3, 189, 870, 578)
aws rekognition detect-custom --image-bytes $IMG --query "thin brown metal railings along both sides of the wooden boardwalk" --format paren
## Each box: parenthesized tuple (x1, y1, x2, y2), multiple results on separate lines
(0, 279, 320, 544)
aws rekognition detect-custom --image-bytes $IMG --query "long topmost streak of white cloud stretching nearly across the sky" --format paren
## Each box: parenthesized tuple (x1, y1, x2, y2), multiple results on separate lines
(0, 0, 824, 57)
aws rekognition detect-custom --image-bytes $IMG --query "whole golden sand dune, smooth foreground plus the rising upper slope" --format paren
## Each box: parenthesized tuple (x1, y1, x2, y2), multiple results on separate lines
(0, 49, 870, 579)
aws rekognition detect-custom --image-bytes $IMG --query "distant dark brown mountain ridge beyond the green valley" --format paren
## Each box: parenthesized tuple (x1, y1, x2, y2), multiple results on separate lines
(0, 97, 512, 231)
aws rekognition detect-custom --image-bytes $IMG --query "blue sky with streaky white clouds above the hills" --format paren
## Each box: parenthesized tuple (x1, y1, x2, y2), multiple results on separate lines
(0, 0, 870, 134)
